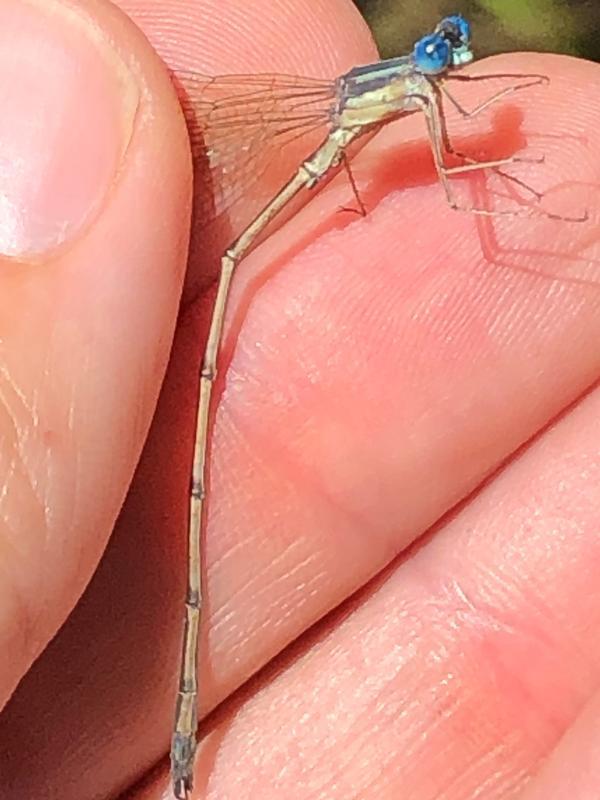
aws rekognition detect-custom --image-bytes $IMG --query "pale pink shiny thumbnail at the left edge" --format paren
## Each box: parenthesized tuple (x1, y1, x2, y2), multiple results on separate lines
(0, 0, 139, 257)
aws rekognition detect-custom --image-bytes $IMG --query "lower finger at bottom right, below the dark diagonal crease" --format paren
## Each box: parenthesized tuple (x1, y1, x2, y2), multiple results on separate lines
(130, 378, 600, 800)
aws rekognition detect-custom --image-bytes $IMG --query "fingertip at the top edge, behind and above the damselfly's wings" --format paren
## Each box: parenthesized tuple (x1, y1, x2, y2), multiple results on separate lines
(119, 0, 377, 78)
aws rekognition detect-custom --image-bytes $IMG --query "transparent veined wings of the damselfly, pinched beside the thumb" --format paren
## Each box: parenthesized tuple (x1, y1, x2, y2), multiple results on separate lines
(173, 71, 337, 252)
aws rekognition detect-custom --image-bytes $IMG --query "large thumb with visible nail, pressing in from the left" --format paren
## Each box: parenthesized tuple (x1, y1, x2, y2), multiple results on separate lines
(0, 0, 191, 707)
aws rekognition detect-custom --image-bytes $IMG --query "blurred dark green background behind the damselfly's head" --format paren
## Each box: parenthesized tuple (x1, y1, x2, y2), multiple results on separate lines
(354, 0, 600, 61)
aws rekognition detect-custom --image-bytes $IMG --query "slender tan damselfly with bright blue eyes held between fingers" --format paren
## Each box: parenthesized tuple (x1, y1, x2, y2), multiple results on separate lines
(166, 15, 585, 800)
